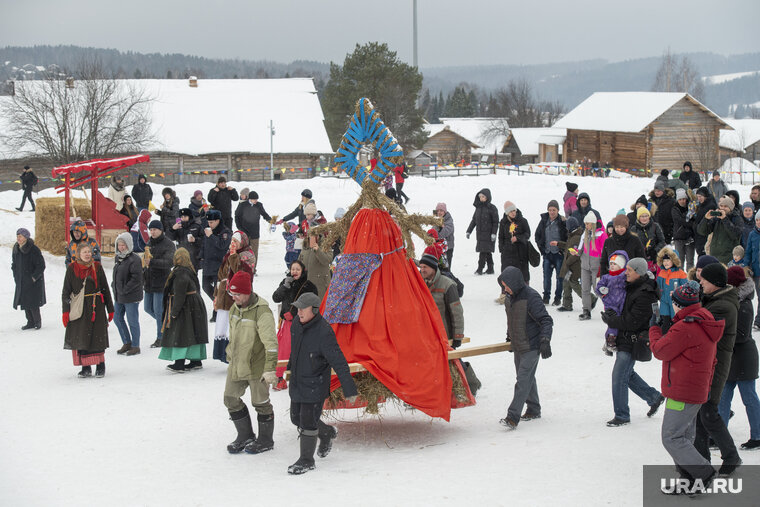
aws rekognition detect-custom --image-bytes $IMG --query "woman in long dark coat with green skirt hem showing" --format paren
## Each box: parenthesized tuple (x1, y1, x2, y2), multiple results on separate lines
(158, 248, 208, 373)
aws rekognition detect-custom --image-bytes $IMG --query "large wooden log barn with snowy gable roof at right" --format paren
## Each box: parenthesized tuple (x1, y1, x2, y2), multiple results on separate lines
(554, 92, 731, 175)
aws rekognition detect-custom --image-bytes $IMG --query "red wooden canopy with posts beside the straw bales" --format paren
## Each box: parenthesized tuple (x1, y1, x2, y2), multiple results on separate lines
(53, 155, 150, 244)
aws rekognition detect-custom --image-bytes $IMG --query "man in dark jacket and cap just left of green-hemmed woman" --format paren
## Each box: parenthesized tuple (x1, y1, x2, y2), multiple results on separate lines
(143, 220, 176, 348)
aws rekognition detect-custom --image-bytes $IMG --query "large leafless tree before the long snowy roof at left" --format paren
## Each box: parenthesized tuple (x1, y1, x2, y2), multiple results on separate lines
(0, 59, 154, 163)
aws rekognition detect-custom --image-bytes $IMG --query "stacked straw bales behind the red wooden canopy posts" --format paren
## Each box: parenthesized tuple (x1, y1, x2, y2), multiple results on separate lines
(34, 197, 92, 255)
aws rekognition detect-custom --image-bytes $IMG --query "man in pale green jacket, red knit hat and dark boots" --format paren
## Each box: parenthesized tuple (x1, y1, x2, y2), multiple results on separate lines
(224, 271, 277, 454)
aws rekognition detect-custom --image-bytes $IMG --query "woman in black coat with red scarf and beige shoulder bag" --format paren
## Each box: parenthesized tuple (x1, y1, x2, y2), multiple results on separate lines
(61, 243, 113, 378)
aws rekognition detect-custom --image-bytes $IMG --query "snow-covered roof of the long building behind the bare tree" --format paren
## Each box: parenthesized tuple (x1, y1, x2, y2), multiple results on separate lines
(0, 78, 333, 158)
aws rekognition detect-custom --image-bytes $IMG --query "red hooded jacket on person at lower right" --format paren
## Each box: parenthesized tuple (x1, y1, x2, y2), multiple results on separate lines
(649, 303, 725, 404)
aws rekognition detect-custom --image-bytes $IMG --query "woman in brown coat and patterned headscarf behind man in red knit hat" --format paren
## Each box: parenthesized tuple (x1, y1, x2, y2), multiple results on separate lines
(213, 231, 256, 363)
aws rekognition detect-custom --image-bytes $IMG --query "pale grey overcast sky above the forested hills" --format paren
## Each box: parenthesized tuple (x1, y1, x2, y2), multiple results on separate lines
(0, 0, 760, 67)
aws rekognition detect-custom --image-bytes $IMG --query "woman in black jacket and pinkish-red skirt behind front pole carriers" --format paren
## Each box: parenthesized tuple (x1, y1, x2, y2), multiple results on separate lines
(272, 260, 318, 391)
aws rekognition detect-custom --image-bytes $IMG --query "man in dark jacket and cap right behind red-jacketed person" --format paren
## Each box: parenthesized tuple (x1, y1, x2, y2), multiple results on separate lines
(694, 262, 742, 475)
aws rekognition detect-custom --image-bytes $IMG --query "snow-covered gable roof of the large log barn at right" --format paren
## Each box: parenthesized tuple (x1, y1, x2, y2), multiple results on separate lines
(554, 92, 725, 132)
